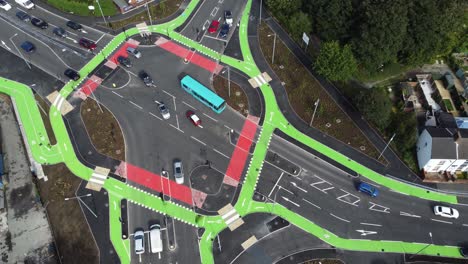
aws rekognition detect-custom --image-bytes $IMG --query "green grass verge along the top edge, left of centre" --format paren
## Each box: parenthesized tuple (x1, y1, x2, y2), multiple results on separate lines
(47, 0, 119, 16)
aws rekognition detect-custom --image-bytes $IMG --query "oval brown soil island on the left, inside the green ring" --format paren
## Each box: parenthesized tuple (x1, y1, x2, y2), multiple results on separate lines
(80, 98, 125, 161)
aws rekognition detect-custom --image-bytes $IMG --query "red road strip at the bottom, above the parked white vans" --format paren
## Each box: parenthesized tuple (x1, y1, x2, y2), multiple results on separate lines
(127, 163, 192, 205)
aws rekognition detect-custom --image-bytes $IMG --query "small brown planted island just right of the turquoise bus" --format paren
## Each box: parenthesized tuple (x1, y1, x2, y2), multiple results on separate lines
(213, 75, 249, 117)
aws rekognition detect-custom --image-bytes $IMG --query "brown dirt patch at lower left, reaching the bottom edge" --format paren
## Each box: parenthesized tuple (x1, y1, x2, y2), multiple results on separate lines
(37, 163, 99, 264)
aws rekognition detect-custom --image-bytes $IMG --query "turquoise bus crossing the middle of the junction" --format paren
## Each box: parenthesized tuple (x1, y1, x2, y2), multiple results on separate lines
(180, 75, 226, 114)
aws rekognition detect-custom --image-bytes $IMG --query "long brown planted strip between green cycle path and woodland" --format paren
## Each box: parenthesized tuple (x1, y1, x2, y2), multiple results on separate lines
(259, 23, 379, 162)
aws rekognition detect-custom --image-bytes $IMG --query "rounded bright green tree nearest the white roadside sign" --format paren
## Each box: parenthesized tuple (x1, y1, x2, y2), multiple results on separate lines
(314, 41, 357, 81)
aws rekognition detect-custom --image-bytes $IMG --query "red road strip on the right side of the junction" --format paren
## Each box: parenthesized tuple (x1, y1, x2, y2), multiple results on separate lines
(226, 119, 257, 182)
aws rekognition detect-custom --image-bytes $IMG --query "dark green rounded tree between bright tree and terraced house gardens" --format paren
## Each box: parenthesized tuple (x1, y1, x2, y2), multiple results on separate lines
(354, 88, 392, 129)
